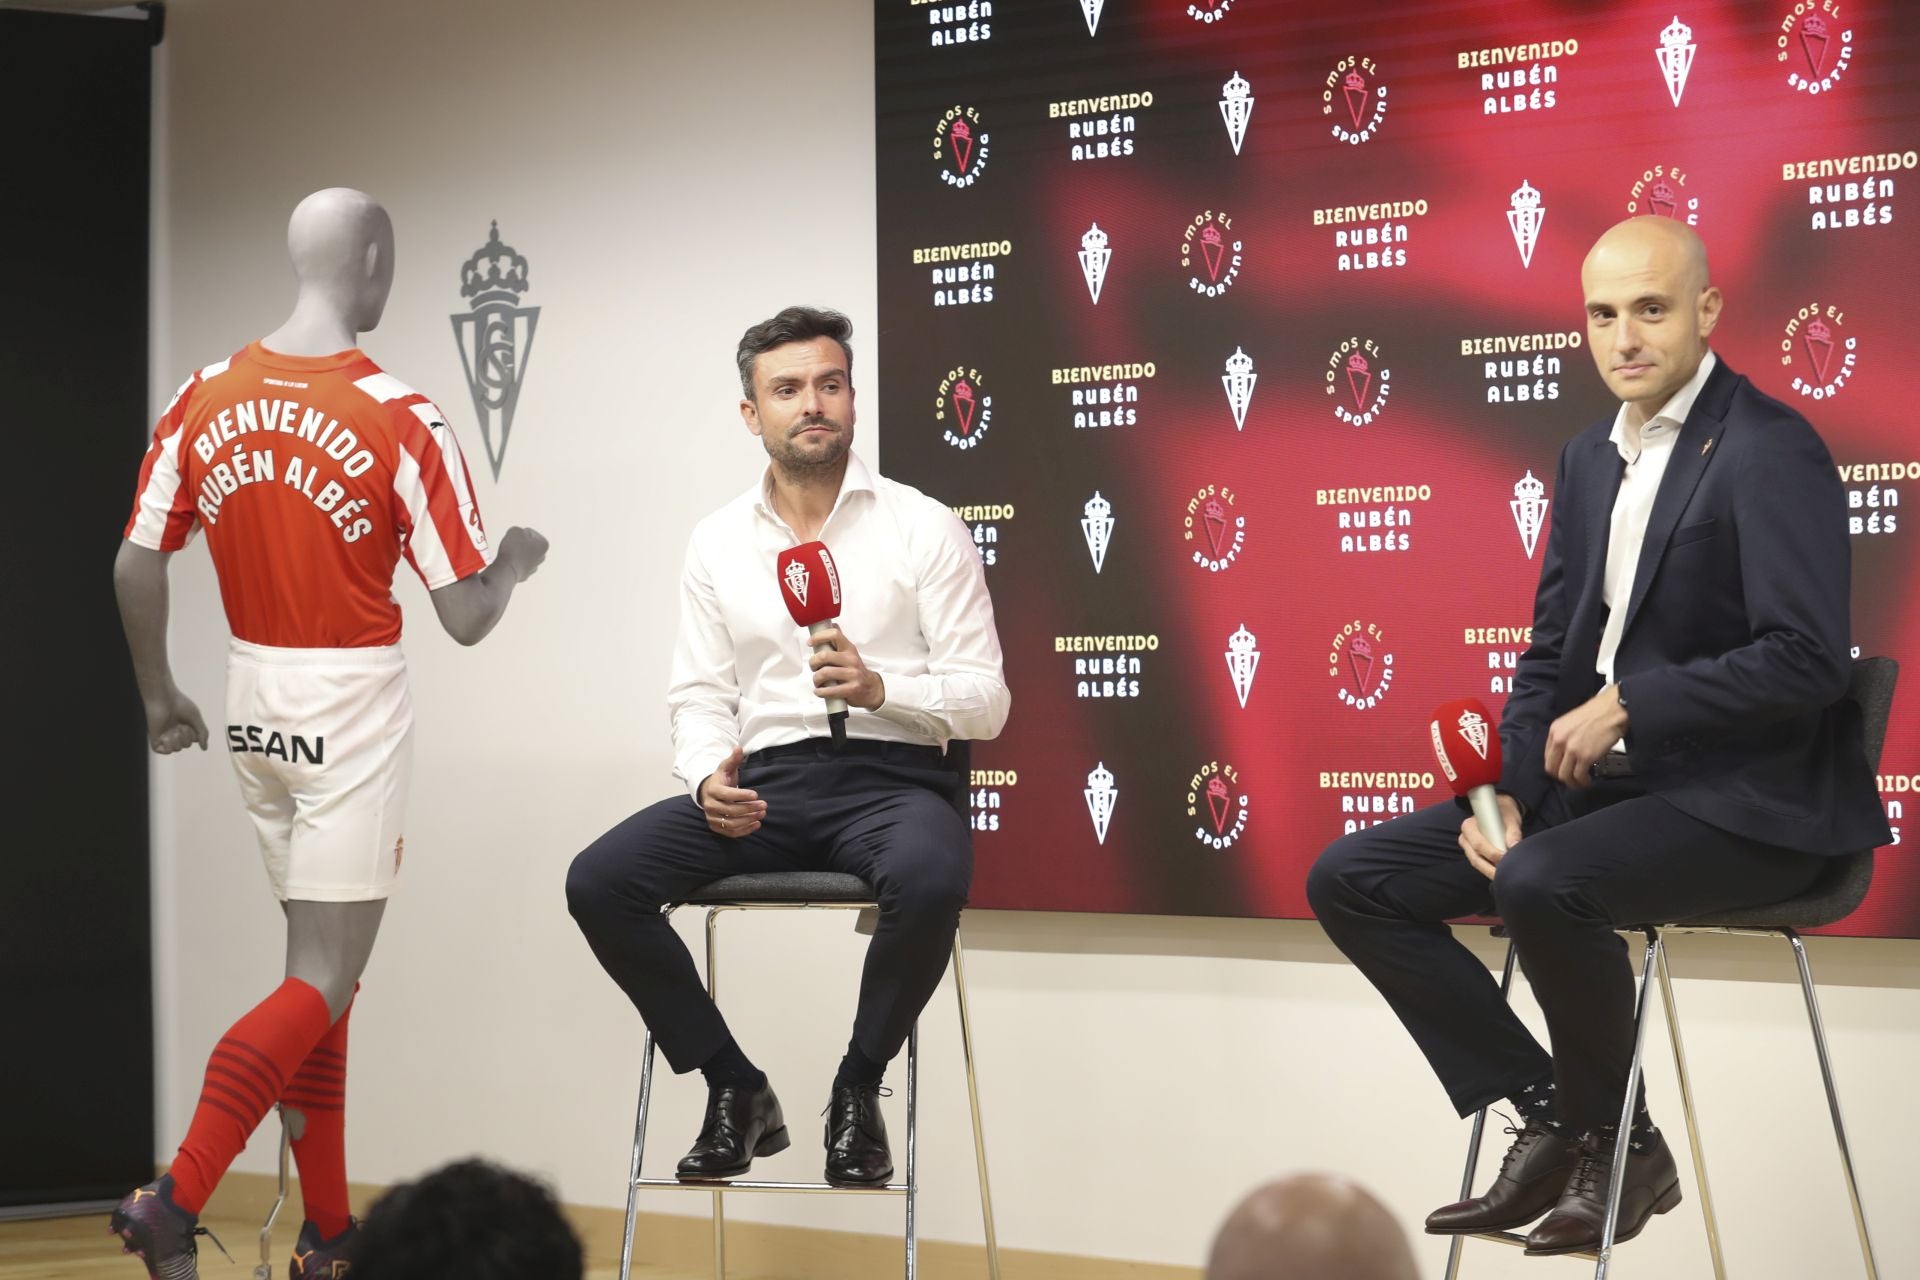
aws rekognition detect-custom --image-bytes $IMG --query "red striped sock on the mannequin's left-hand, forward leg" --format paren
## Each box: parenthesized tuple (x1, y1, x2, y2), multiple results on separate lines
(169, 979, 330, 1213)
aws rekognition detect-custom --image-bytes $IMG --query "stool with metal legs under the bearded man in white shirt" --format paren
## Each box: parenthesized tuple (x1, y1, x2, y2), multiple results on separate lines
(620, 743, 1000, 1280)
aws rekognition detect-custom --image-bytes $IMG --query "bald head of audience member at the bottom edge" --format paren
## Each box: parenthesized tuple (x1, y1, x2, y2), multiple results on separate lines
(1206, 1173, 1421, 1280)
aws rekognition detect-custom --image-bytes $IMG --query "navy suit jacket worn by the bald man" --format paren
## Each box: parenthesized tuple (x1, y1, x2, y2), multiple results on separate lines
(1500, 361, 1891, 854)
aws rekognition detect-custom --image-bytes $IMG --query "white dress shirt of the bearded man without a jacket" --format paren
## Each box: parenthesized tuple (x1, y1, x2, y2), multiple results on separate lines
(666, 455, 1012, 800)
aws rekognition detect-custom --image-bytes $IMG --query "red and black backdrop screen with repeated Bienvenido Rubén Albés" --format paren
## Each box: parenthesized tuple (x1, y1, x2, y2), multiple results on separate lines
(876, 0, 1920, 936)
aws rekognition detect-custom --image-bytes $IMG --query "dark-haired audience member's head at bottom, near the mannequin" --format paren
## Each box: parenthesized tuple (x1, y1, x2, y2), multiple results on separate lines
(353, 1159, 582, 1280)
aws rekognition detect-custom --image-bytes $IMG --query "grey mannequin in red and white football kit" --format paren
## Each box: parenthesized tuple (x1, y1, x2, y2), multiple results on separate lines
(113, 188, 547, 1280)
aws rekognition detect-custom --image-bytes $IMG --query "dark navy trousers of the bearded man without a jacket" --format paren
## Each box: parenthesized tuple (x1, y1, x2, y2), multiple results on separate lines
(566, 739, 973, 1071)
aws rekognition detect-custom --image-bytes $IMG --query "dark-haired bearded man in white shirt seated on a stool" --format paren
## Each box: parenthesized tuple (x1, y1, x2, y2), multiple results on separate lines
(566, 307, 1010, 1186)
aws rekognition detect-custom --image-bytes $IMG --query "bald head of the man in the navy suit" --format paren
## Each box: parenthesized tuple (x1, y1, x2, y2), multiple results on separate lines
(1580, 217, 1720, 426)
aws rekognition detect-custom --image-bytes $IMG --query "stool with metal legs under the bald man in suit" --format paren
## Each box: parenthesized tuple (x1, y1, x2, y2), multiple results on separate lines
(1446, 658, 1899, 1280)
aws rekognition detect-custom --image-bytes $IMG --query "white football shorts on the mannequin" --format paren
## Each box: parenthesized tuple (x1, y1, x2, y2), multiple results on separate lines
(227, 639, 413, 902)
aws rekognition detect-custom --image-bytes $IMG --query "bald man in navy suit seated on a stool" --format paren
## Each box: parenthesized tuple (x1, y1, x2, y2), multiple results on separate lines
(1308, 217, 1891, 1255)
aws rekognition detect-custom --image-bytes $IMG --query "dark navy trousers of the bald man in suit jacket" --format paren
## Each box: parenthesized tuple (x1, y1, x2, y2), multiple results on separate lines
(1308, 779, 1826, 1134)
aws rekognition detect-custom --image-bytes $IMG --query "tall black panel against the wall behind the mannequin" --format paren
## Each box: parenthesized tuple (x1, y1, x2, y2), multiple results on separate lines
(0, 12, 154, 1207)
